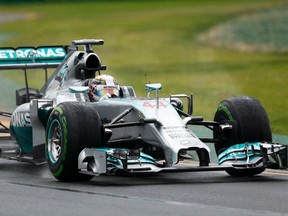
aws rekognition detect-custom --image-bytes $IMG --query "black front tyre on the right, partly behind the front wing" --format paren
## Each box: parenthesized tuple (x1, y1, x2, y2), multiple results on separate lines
(213, 96, 272, 176)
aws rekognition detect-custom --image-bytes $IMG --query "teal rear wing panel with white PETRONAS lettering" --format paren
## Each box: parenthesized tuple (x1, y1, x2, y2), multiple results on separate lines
(0, 46, 68, 70)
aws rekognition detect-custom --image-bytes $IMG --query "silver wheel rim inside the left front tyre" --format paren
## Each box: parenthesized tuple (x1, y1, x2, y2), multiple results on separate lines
(47, 120, 62, 164)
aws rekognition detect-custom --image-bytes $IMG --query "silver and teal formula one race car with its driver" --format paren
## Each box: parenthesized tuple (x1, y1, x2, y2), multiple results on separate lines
(0, 39, 287, 181)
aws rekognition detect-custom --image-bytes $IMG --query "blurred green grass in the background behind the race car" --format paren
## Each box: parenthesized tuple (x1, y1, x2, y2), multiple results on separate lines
(0, 0, 288, 134)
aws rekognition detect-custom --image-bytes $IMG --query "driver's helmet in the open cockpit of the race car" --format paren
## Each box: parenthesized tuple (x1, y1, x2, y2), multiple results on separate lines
(89, 74, 120, 97)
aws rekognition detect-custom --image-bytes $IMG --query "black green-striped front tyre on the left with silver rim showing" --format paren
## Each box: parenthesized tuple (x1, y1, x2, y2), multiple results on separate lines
(46, 102, 104, 182)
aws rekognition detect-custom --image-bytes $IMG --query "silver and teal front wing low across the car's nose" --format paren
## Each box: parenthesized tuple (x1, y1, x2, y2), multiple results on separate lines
(78, 142, 286, 175)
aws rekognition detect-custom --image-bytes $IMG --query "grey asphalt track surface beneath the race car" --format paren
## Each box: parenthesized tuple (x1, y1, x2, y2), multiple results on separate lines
(0, 159, 288, 216)
